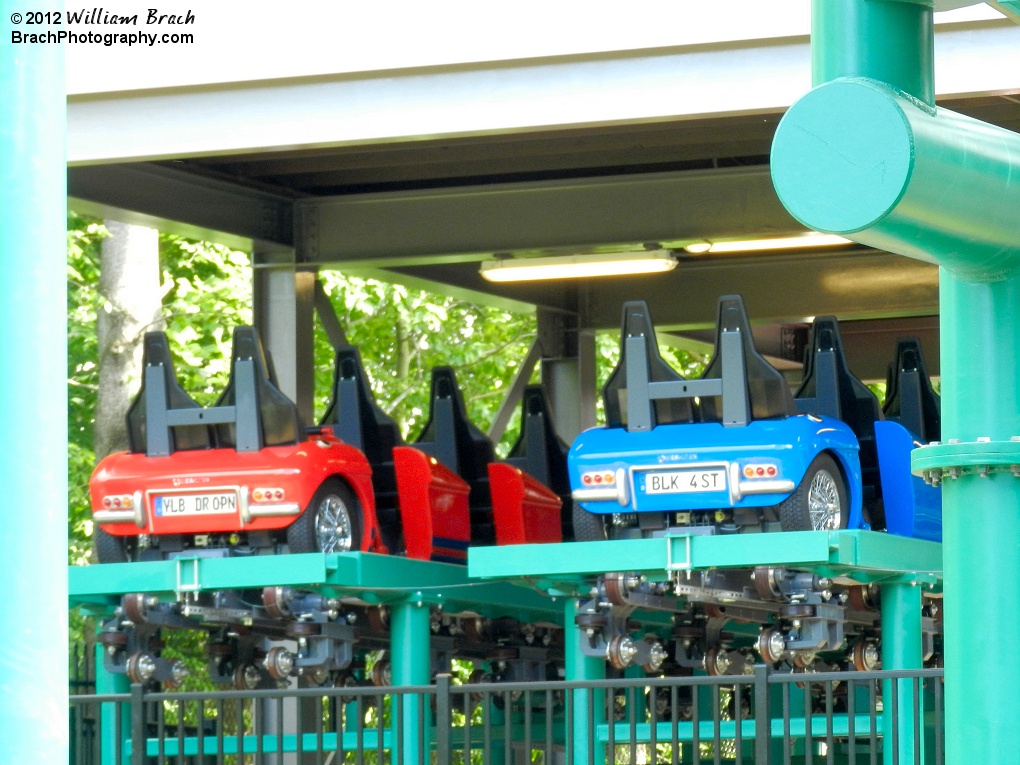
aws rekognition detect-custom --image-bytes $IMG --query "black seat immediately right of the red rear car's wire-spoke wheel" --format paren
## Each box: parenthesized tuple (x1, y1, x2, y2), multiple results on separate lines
(319, 346, 404, 551)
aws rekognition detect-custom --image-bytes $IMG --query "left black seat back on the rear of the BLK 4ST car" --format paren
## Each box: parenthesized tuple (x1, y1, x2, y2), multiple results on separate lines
(602, 300, 696, 427)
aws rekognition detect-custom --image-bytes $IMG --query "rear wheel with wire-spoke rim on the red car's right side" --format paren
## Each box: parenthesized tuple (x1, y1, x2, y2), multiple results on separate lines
(287, 478, 362, 553)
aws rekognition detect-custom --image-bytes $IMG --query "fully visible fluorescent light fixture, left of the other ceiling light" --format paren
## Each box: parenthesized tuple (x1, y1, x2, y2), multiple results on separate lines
(480, 250, 676, 282)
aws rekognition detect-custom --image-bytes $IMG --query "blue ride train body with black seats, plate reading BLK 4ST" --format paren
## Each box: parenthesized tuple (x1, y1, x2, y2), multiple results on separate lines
(567, 296, 941, 541)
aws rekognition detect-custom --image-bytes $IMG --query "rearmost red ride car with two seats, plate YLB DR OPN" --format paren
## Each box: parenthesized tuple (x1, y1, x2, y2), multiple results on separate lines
(90, 326, 388, 563)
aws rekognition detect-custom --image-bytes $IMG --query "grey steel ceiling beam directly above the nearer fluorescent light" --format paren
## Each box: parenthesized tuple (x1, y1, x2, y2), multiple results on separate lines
(306, 166, 804, 268)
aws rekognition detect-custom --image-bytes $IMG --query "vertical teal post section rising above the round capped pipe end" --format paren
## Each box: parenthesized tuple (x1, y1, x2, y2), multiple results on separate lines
(811, 0, 935, 105)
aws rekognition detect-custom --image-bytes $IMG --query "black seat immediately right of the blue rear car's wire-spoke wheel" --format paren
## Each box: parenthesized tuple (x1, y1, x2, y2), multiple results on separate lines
(795, 316, 882, 516)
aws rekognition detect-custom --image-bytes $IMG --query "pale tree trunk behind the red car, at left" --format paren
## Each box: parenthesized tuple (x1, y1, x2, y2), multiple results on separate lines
(94, 220, 163, 461)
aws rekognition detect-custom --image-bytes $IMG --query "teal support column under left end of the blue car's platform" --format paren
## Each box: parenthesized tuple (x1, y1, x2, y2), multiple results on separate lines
(563, 598, 606, 765)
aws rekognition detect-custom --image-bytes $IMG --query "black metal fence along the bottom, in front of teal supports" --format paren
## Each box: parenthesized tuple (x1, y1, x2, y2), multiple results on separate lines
(70, 666, 944, 765)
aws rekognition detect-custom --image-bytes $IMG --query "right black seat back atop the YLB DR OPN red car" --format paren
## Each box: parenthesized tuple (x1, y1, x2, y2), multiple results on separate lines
(213, 326, 304, 452)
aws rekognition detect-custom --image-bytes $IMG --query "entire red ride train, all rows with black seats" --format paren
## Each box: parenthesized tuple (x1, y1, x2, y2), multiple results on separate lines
(91, 326, 569, 563)
